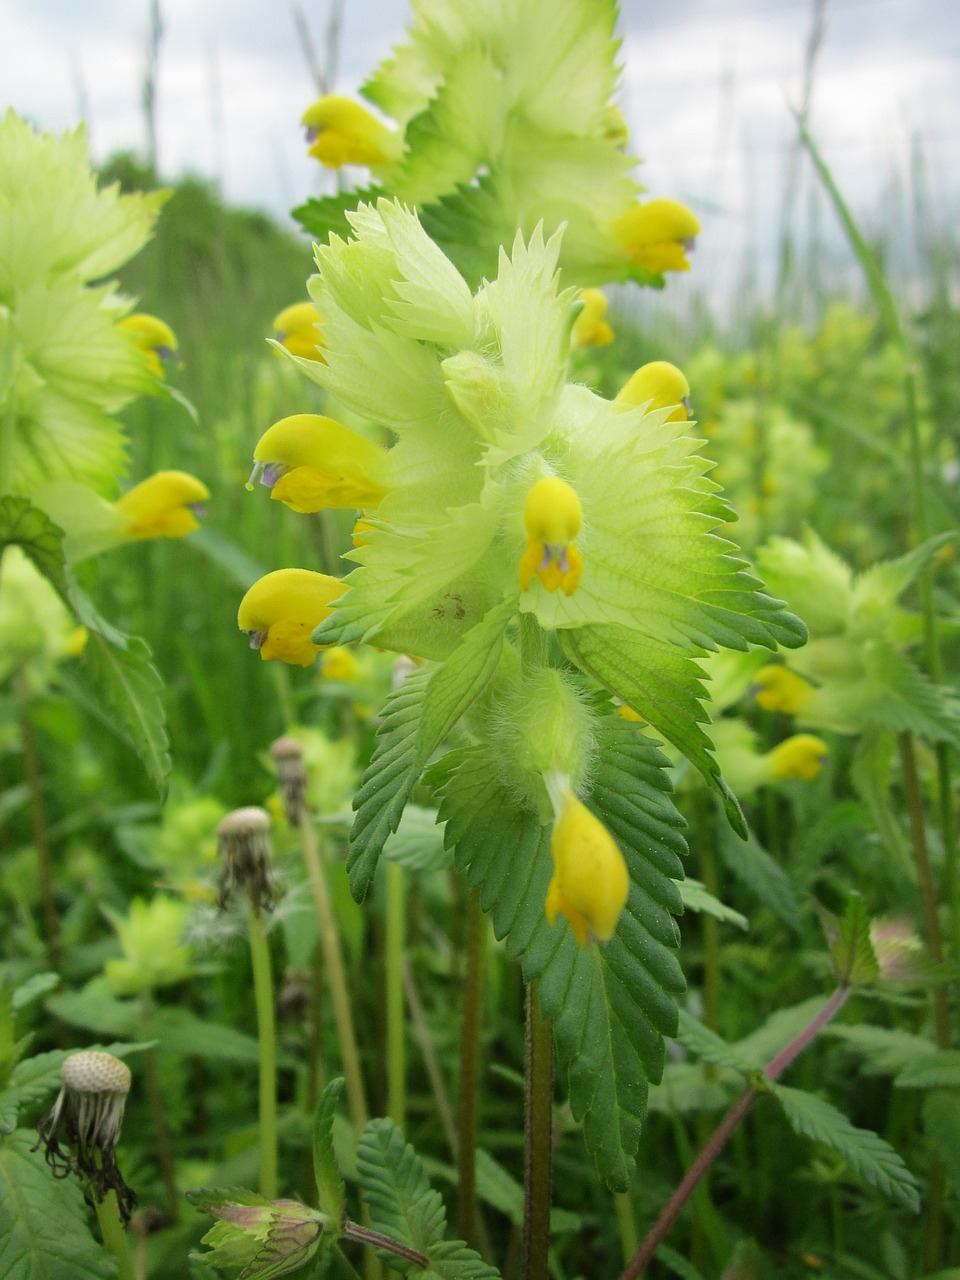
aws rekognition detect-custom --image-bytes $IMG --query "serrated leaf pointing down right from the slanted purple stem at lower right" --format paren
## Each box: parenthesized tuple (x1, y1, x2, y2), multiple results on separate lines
(771, 1084, 920, 1213)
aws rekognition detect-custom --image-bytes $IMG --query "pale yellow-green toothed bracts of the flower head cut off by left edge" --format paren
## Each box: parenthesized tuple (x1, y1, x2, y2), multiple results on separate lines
(0, 111, 166, 494)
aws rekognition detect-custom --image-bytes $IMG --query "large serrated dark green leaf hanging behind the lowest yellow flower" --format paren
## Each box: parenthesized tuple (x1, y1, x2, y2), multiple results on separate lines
(440, 716, 685, 1189)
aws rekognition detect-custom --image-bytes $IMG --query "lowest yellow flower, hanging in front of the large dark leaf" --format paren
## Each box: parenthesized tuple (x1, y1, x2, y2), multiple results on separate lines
(544, 790, 630, 947)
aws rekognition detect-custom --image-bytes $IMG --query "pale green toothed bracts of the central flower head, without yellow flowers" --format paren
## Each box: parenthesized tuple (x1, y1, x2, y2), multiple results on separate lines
(289, 201, 804, 798)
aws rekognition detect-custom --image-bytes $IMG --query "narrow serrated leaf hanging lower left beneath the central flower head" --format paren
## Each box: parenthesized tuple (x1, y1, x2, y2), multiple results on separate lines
(347, 669, 433, 902)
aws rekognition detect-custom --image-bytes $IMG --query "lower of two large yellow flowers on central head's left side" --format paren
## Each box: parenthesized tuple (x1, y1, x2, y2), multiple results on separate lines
(237, 568, 347, 667)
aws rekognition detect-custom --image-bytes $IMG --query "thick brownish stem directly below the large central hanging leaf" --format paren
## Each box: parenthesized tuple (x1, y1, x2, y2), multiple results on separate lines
(521, 982, 553, 1280)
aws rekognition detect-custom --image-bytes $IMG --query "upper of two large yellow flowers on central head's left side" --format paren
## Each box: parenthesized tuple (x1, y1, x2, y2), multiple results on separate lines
(247, 413, 387, 512)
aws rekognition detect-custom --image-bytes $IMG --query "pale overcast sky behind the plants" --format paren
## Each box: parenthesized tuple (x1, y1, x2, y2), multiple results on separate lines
(0, 0, 960, 307)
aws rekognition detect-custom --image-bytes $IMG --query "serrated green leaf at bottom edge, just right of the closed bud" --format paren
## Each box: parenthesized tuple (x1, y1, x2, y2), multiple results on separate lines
(357, 1120, 499, 1280)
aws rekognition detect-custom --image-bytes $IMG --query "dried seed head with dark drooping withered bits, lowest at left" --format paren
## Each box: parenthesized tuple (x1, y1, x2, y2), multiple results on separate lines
(35, 1050, 137, 1222)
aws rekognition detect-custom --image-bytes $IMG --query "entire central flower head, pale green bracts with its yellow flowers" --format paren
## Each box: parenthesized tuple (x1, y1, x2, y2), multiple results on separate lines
(238, 201, 803, 940)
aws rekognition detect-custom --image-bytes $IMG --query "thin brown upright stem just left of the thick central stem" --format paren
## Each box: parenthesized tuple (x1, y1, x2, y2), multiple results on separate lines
(457, 890, 486, 1243)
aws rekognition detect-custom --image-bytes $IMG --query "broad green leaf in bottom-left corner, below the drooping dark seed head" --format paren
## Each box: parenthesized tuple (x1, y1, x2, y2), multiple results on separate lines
(0, 1132, 116, 1280)
